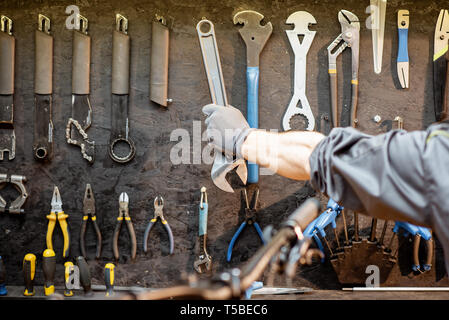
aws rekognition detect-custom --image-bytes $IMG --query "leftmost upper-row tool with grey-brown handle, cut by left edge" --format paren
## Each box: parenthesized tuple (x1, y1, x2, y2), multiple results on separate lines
(0, 15, 16, 160)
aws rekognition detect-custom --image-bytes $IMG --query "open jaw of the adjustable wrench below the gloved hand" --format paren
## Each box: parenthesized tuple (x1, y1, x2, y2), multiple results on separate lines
(211, 153, 248, 193)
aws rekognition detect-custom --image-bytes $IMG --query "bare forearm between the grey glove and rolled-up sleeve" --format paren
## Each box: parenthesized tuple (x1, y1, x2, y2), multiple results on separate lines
(241, 130, 324, 180)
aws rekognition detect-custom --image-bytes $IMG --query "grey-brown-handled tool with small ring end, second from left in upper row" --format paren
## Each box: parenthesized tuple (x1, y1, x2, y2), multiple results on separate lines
(33, 14, 53, 160)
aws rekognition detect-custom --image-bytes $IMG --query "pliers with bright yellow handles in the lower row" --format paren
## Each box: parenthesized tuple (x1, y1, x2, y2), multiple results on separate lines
(47, 186, 70, 258)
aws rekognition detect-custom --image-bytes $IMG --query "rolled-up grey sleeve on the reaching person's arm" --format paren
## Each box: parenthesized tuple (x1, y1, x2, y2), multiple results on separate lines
(310, 127, 432, 225)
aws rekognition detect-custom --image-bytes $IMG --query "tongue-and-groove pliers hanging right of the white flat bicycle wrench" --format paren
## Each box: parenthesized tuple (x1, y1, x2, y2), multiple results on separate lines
(327, 10, 360, 128)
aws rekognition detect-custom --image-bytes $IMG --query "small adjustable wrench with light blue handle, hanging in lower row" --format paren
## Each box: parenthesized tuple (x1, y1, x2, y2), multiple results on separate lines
(193, 187, 212, 273)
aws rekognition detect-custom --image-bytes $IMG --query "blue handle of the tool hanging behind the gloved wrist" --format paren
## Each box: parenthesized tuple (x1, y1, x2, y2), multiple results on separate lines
(246, 67, 259, 183)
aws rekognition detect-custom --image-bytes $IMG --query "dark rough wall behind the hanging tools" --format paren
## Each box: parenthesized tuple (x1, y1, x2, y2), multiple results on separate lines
(0, 0, 447, 288)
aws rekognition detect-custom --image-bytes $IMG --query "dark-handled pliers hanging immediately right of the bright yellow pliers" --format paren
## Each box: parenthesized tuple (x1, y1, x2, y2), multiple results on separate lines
(80, 184, 101, 259)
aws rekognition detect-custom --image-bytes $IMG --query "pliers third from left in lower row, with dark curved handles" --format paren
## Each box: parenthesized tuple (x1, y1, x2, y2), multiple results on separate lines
(112, 192, 137, 260)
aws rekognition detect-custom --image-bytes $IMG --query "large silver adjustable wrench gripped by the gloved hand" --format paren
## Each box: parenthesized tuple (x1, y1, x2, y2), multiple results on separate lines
(196, 19, 248, 192)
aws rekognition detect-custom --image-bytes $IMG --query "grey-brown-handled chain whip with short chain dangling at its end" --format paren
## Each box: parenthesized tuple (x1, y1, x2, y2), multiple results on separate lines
(66, 14, 95, 163)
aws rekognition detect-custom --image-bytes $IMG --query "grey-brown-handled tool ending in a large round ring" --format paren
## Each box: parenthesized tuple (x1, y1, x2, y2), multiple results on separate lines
(109, 14, 136, 163)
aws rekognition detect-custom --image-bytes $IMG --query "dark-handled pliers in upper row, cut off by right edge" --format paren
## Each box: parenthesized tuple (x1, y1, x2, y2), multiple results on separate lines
(433, 10, 449, 121)
